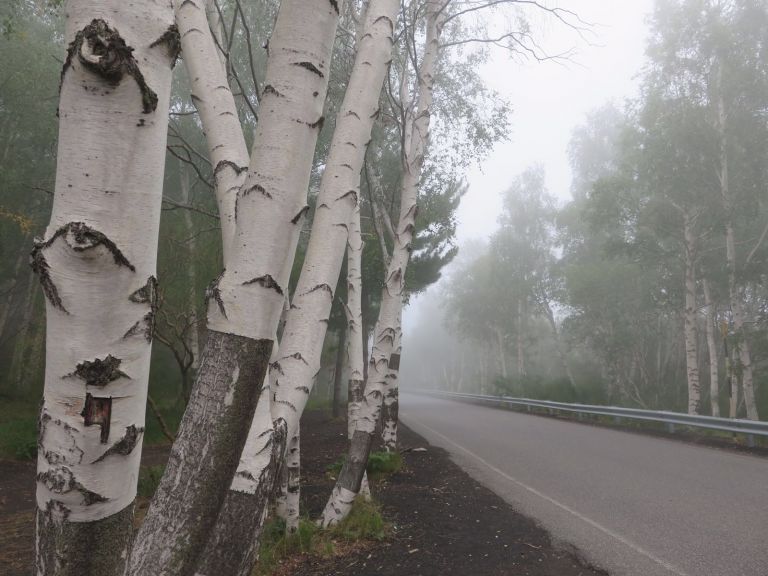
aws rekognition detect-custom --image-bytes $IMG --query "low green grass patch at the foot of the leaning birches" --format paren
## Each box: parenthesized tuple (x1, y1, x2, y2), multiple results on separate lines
(253, 498, 389, 576)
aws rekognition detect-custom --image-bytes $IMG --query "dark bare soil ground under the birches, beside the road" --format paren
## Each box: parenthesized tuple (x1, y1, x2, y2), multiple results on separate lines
(0, 411, 604, 576)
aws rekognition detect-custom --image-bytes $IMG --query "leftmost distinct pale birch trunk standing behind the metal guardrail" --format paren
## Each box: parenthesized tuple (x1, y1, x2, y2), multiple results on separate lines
(683, 212, 701, 414)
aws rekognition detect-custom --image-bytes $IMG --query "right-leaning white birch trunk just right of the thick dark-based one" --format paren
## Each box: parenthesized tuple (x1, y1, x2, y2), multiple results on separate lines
(272, 0, 398, 444)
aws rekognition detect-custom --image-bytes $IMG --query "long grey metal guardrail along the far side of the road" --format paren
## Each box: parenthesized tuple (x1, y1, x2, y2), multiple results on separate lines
(412, 390, 768, 447)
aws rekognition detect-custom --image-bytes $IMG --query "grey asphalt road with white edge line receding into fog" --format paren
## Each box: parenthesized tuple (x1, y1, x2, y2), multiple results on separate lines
(400, 391, 768, 576)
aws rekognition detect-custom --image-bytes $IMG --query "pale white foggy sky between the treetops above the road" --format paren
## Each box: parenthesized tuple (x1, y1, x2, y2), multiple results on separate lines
(403, 0, 653, 333)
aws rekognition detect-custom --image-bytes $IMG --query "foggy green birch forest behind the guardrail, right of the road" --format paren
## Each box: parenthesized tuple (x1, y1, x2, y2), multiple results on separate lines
(403, 2, 768, 419)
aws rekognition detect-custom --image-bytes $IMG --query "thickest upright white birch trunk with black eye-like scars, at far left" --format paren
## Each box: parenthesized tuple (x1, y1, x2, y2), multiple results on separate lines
(32, 0, 178, 576)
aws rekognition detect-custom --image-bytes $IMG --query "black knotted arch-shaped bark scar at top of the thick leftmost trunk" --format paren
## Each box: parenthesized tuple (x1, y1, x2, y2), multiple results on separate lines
(61, 18, 157, 114)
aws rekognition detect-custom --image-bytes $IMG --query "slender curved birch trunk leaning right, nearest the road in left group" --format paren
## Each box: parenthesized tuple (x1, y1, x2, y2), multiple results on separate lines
(321, 0, 440, 526)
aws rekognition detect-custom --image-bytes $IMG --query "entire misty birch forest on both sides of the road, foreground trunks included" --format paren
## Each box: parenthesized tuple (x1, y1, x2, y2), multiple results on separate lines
(0, 0, 768, 576)
